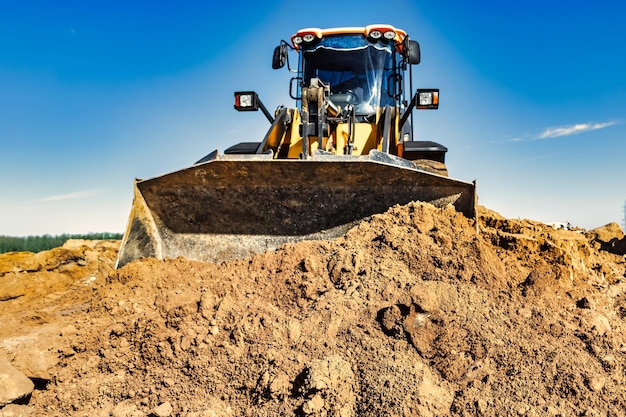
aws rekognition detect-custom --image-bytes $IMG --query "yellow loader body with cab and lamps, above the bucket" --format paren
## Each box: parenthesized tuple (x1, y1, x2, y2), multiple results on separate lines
(227, 25, 438, 162)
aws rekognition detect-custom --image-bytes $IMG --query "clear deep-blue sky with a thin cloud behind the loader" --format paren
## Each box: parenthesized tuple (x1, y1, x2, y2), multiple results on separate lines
(0, 0, 626, 236)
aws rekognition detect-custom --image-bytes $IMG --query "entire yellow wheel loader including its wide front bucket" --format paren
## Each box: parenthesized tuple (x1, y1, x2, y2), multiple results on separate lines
(116, 24, 476, 267)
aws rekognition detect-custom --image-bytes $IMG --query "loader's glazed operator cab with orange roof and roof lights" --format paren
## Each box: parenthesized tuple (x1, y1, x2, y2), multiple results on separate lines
(282, 25, 419, 121)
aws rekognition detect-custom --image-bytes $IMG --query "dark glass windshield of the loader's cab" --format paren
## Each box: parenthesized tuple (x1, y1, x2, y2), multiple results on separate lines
(302, 35, 394, 115)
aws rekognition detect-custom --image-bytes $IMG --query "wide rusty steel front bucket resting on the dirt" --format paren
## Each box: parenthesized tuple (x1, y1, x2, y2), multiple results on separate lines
(116, 151, 476, 267)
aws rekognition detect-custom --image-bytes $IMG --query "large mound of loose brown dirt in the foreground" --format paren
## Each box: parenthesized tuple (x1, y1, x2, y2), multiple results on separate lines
(0, 203, 626, 417)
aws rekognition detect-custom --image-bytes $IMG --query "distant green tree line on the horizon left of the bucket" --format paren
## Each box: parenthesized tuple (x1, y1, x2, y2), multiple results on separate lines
(0, 233, 122, 253)
